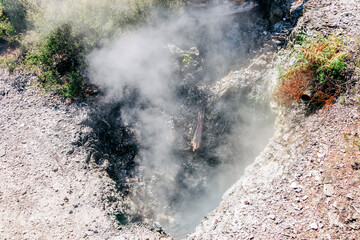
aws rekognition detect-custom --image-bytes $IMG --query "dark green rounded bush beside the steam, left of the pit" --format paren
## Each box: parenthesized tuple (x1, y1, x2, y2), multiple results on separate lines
(25, 24, 85, 98)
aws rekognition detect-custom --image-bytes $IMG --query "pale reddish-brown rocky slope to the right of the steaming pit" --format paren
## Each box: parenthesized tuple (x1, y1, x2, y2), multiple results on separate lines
(189, 0, 360, 239)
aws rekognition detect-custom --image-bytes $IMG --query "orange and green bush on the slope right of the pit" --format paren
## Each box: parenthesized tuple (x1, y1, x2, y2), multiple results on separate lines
(274, 35, 349, 110)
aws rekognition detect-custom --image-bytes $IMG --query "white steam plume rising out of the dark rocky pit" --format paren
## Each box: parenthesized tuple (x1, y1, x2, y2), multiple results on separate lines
(89, 4, 272, 236)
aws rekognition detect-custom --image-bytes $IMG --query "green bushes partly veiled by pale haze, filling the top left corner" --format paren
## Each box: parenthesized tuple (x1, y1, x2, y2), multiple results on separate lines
(0, 0, 183, 98)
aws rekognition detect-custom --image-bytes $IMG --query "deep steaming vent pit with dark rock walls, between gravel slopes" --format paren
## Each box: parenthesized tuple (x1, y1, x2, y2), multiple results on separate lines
(84, 1, 274, 238)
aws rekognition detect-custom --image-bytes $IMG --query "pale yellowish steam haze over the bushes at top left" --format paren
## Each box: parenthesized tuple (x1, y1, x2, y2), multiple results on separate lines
(25, 0, 173, 47)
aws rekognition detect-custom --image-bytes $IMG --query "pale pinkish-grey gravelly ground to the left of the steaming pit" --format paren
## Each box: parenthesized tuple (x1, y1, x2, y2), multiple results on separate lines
(0, 72, 121, 239)
